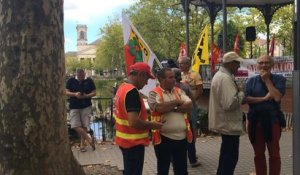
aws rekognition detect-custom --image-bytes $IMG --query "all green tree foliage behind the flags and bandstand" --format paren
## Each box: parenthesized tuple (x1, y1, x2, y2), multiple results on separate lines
(93, 0, 293, 72)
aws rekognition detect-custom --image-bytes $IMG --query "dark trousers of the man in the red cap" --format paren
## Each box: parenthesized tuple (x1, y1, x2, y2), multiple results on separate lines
(120, 145, 145, 175)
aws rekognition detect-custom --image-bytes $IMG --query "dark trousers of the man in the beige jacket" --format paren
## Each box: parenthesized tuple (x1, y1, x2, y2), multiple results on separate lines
(217, 134, 240, 175)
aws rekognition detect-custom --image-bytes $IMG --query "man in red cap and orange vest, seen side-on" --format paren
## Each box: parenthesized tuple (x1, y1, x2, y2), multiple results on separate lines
(115, 62, 162, 175)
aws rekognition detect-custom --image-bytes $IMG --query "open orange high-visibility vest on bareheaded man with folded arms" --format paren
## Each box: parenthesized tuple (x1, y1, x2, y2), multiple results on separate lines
(151, 86, 193, 145)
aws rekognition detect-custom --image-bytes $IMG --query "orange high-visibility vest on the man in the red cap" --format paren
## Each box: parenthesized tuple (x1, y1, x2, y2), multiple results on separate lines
(115, 83, 149, 148)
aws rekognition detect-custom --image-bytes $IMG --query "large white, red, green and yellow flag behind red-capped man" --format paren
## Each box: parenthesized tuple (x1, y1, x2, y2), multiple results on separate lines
(122, 13, 161, 96)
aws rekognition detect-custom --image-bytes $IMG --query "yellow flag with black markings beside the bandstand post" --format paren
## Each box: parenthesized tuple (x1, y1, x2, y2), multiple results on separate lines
(192, 25, 209, 72)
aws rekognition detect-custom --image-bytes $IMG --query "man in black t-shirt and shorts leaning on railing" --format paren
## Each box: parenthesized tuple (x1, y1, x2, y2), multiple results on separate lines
(66, 69, 96, 152)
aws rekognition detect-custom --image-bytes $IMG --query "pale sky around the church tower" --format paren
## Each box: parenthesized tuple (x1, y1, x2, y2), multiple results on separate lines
(64, 0, 136, 52)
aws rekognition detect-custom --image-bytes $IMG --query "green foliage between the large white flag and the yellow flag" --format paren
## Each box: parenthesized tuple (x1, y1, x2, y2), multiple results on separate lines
(126, 0, 209, 60)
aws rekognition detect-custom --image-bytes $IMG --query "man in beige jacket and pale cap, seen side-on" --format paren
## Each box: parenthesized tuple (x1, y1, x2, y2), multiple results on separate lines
(208, 52, 245, 175)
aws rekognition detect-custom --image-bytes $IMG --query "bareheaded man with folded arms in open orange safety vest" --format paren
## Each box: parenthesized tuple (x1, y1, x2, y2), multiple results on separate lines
(148, 68, 193, 175)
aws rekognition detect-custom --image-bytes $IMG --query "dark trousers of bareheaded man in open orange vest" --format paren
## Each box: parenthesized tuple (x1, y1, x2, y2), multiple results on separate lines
(154, 135, 188, 175)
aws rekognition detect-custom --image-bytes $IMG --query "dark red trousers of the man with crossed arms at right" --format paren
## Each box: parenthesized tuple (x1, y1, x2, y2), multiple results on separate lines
(248, 122, 281, 175)
